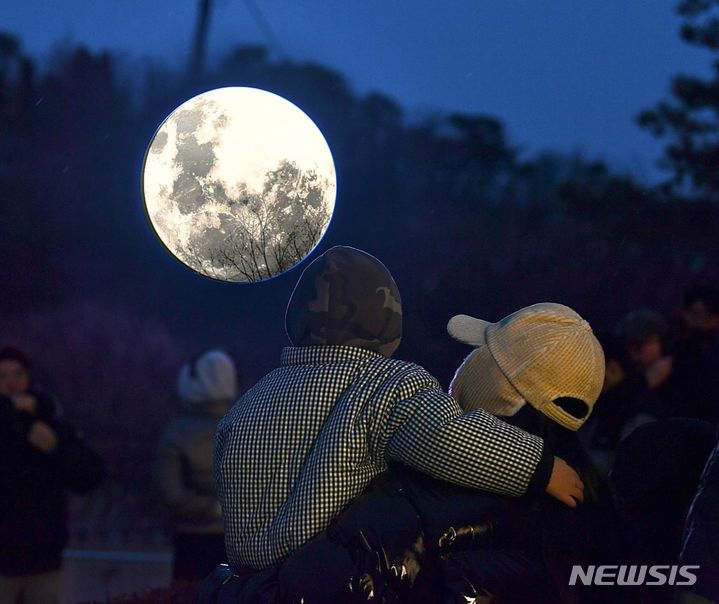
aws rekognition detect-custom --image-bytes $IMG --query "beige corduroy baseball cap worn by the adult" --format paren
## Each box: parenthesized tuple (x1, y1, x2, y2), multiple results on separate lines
(447, 302, 604, 430)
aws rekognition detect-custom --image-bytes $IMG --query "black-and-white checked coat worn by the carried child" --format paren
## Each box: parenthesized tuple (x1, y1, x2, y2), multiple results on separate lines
(214, 346, 543, 569)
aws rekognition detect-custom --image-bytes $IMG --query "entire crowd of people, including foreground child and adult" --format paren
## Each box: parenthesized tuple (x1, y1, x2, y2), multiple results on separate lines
(0, 247, 719, 604)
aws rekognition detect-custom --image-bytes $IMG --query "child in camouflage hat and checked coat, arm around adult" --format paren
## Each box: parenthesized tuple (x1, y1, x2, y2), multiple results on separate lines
(210, 246, 583, 601)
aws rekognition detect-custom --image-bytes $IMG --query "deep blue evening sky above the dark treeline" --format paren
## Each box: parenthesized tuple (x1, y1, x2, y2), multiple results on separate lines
(0, 0, 709, 180)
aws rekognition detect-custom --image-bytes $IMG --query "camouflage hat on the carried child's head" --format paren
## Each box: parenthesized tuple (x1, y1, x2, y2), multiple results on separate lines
(285, 246, 402, 356)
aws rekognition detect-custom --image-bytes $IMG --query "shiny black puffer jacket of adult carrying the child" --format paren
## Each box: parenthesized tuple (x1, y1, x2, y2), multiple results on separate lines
(205, 465, 556, 604)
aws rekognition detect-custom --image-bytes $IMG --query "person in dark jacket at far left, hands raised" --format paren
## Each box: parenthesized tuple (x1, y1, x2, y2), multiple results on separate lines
(0, 348, 104, 604)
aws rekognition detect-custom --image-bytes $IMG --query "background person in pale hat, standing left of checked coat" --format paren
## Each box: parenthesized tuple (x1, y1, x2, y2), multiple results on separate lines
(155, 350, 237, 581)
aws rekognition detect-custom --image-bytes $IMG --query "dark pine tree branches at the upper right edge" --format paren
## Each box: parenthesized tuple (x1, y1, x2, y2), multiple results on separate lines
(638, 0, 719, 202)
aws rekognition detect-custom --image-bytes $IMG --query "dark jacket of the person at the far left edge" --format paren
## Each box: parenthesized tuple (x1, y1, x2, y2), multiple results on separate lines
(0, 392, 104, 576)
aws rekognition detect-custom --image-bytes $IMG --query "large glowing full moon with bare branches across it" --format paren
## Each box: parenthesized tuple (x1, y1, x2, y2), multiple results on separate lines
(142, 87, 337, 282)
